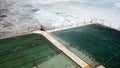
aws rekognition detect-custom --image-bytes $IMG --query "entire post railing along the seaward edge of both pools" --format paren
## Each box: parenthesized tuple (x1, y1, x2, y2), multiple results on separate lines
(0, 19, 120, 39)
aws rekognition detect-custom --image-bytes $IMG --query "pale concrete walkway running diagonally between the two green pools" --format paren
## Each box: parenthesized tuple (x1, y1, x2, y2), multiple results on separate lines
(33, 31, 92, 68)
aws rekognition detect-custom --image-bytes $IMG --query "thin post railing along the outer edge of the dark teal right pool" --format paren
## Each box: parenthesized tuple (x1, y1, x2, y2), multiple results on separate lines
(47, 19, 120, 30)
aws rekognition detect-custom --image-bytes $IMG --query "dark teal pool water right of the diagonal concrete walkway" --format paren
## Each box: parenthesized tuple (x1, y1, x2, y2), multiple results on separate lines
(50, 24, 120, 68)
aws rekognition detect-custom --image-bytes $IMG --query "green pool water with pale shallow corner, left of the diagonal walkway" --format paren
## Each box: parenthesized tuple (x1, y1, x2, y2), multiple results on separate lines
(0, 34, 77, 68)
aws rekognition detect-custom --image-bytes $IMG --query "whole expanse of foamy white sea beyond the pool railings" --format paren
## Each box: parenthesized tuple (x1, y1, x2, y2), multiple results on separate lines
(0, 0, 120, 35)
